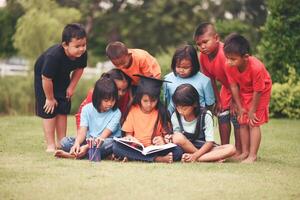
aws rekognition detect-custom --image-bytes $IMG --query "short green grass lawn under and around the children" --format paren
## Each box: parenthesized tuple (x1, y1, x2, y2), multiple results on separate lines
(0, 116, 300, 200)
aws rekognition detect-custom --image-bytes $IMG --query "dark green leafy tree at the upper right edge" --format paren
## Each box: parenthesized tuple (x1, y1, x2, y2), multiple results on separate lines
(259, 0, 300, 83)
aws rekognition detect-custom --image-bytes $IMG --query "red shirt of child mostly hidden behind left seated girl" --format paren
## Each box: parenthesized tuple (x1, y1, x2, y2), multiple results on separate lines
(75, 89, 130, 129)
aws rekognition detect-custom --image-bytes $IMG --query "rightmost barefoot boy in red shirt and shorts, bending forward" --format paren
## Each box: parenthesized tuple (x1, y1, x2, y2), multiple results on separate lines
(224, 33, 272, 163)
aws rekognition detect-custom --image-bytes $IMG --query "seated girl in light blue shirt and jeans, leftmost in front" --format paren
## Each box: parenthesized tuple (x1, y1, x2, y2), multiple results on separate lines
(55, 77, 121, 158)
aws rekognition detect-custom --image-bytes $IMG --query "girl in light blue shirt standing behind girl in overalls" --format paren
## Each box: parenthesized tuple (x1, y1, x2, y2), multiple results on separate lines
(164, 45, 215, 115)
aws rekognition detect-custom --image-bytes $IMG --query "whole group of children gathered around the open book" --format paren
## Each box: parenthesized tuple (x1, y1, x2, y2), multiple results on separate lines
(35, 23, 272, 163)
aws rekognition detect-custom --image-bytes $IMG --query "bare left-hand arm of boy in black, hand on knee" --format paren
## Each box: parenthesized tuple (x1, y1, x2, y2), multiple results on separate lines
(42, 75, 57, 114)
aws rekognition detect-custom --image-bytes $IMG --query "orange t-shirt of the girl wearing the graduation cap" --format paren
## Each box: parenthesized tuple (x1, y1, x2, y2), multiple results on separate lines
(122, 105, 164, 147)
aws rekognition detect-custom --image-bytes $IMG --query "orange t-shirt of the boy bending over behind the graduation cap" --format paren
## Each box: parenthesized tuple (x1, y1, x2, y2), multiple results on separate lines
(121, 49, 161, 85)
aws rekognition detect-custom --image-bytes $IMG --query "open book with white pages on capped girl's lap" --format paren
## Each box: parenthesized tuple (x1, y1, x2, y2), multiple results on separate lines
(114, 137, 176, 155)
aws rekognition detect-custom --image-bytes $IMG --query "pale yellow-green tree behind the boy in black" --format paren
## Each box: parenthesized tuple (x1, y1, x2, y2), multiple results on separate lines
(14, 0, 81, 61)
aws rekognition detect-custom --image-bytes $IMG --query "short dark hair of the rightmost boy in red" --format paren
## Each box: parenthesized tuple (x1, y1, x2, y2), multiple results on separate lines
(223, 33, 250, 56)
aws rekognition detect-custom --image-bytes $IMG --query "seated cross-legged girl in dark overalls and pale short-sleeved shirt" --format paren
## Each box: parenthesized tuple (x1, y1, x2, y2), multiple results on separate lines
(171, 84, 236, 162)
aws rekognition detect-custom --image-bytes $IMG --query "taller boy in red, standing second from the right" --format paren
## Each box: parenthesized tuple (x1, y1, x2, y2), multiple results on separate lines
(194, 23, 241, 155)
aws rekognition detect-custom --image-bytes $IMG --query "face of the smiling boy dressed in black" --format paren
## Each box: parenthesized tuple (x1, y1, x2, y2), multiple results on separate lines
(62, 38, 86, 59)
